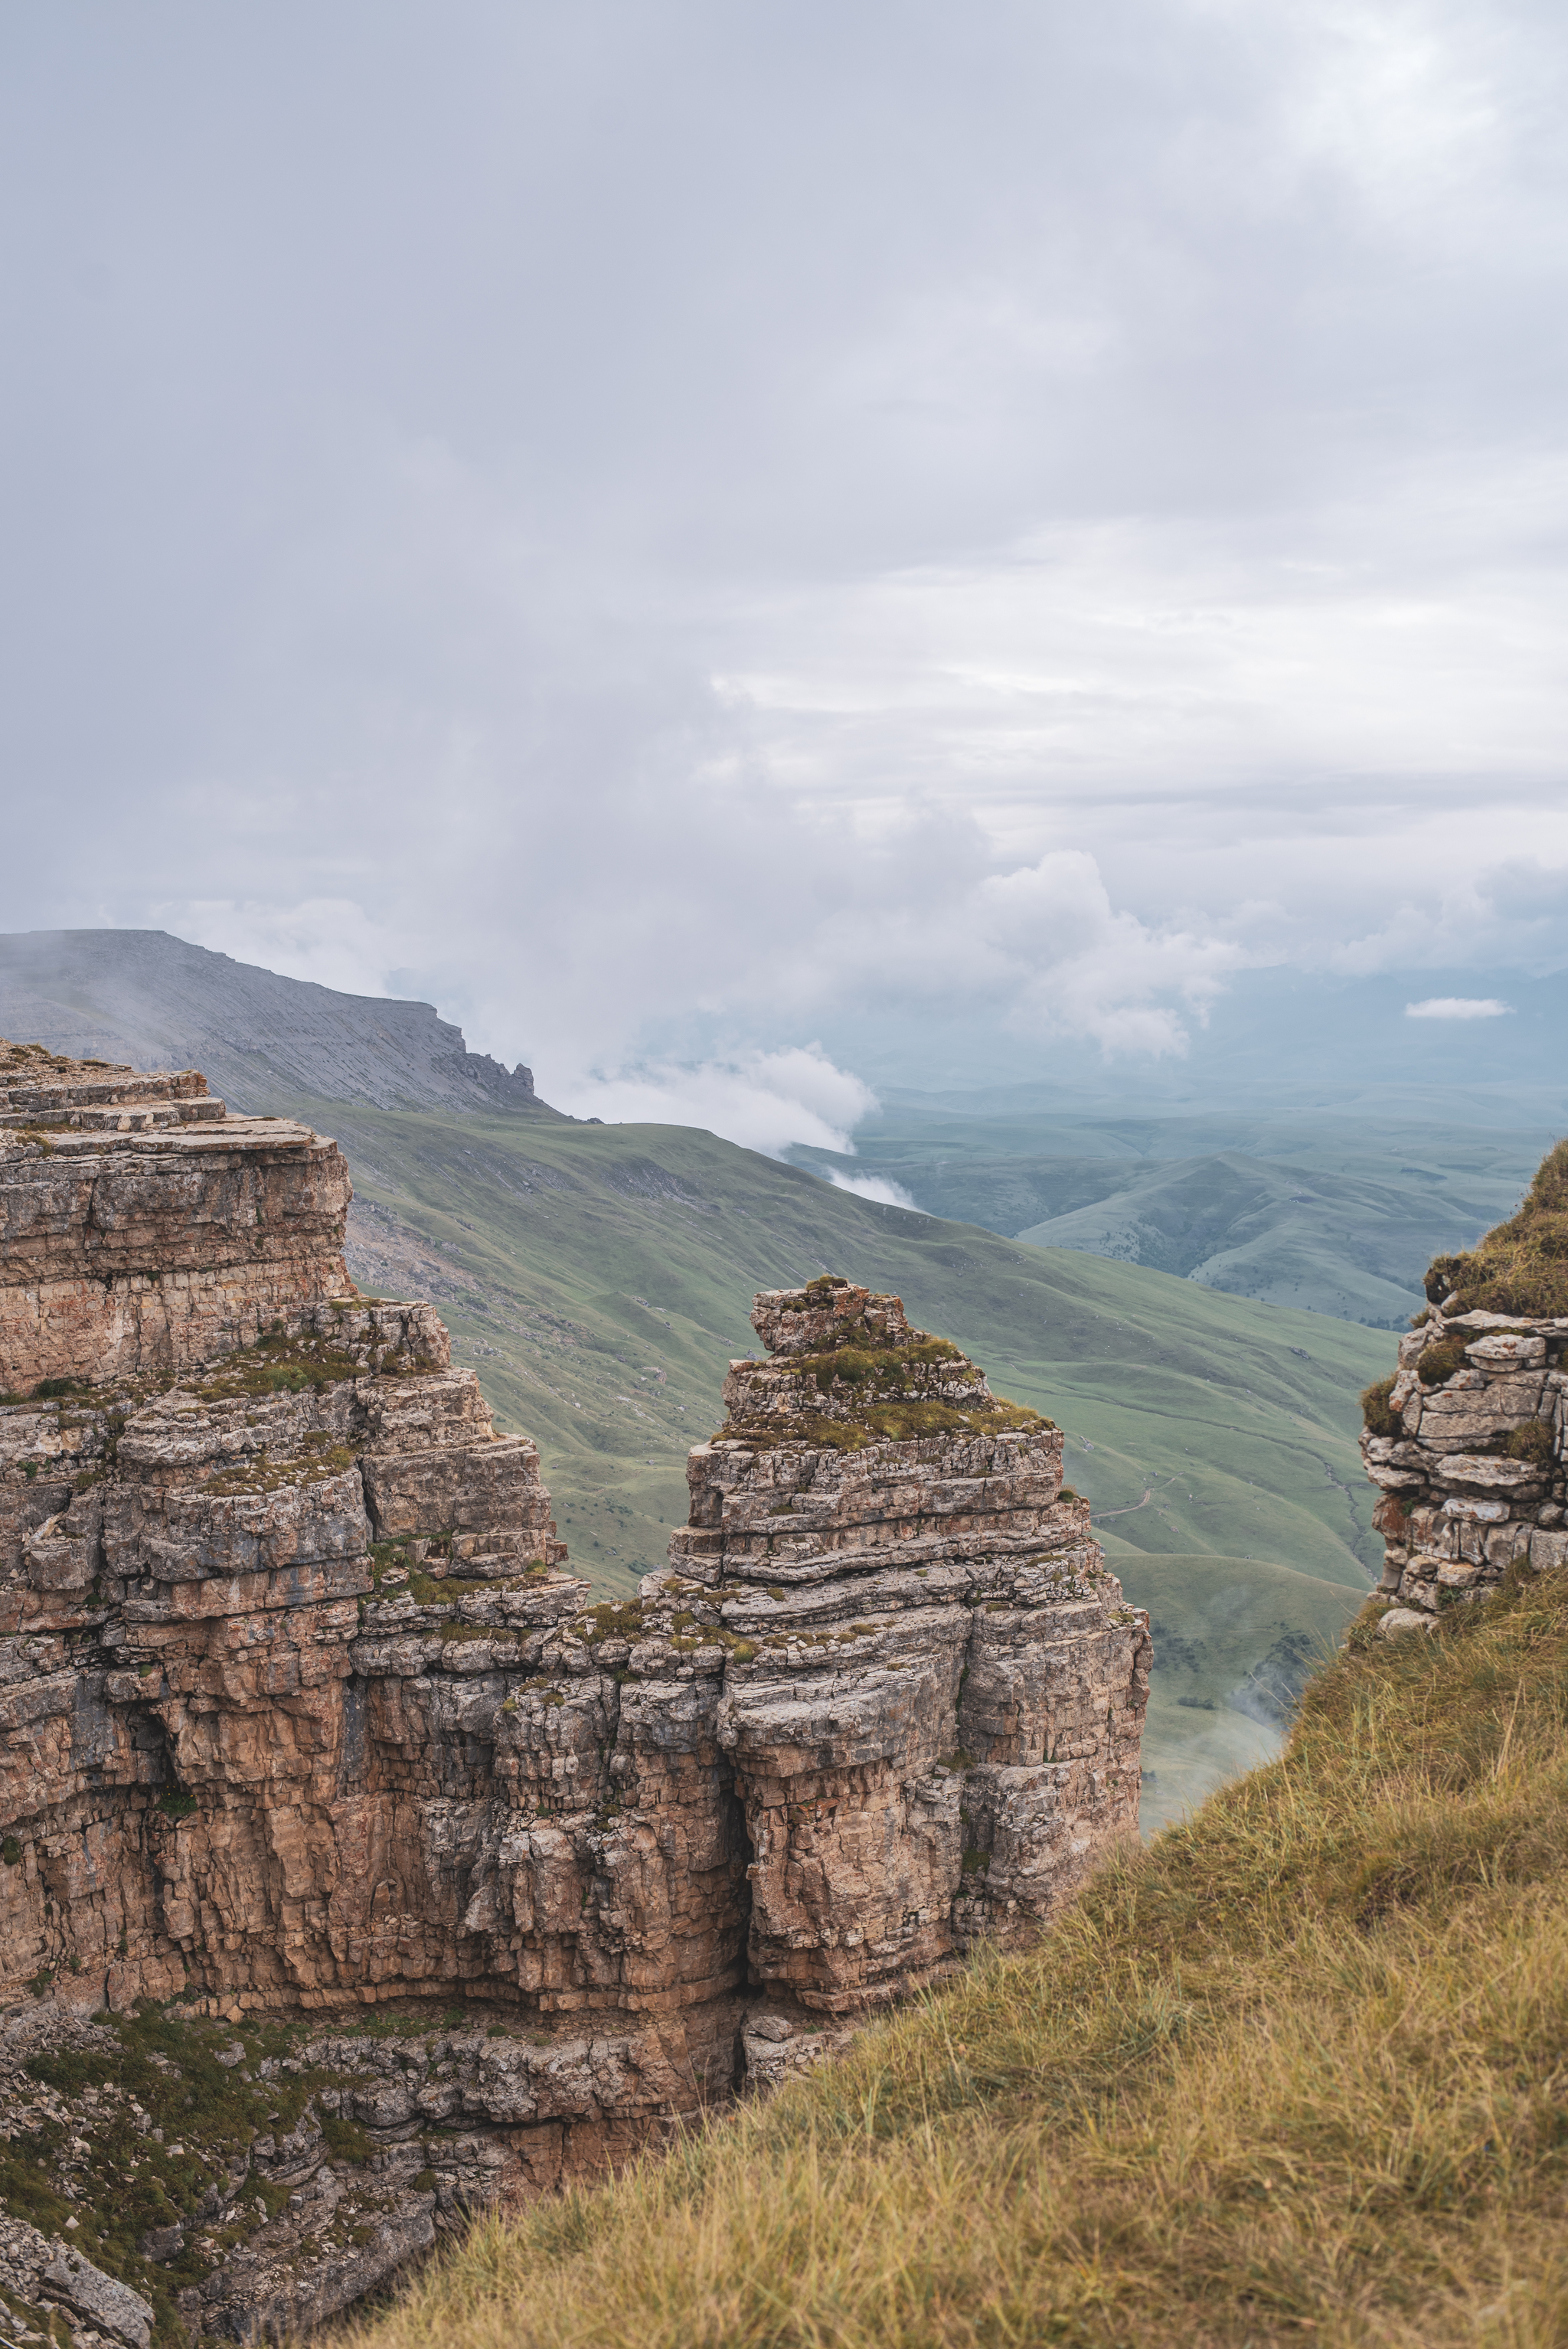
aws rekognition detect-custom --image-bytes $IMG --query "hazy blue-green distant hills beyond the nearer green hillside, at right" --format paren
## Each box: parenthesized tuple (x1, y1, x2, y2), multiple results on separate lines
(795, 1109, 1547, 1327)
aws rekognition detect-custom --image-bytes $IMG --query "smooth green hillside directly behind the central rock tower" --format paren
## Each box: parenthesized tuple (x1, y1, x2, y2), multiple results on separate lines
(278, 1099, 1392, 1818)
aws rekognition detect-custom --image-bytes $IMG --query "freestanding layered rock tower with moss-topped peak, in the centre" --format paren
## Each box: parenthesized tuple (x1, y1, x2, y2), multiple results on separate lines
(662, 1282, 1150, 2013)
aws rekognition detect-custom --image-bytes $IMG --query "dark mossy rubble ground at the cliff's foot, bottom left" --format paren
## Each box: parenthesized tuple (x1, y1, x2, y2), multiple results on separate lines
(0, 2001, 848, 2349)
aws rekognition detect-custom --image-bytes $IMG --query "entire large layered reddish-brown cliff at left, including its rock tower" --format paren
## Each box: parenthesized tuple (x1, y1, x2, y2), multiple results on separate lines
(0, 1052, 1150, 2349)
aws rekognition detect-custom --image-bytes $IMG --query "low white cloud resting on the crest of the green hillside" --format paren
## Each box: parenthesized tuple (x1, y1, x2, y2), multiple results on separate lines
(547, 1045, 878, 1158)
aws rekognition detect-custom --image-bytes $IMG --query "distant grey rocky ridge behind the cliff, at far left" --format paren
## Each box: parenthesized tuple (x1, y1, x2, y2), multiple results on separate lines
(0, 930, 559, 1118)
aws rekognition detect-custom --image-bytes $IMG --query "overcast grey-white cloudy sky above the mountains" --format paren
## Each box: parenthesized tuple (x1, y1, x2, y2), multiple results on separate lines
(0, 0, 1568, 1146)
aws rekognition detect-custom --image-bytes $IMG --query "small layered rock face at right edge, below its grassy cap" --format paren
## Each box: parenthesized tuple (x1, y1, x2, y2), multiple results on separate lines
(1361, 1313, 1568, 1628)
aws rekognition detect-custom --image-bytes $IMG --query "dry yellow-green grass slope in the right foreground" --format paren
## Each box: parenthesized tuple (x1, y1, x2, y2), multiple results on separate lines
(345, 1576, 1568, 2349)
